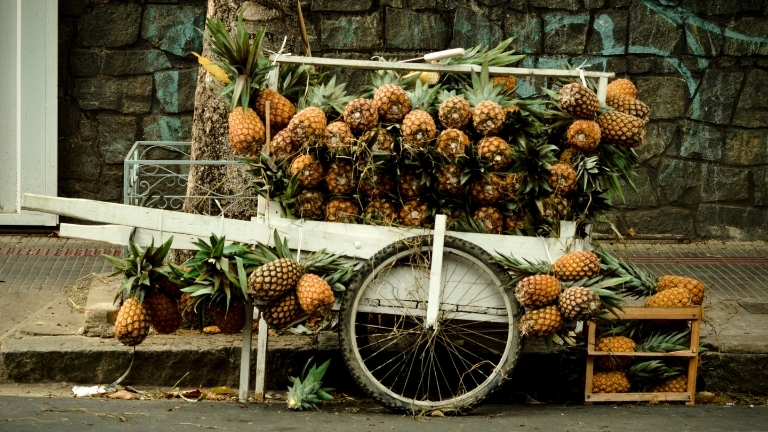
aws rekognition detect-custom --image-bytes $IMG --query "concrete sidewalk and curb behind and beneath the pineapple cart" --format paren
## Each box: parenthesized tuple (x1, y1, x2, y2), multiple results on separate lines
(0, 235, 768, 394)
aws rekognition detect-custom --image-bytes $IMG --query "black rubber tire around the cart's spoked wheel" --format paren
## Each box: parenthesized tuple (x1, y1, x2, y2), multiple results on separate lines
(339, 236, 522, 414)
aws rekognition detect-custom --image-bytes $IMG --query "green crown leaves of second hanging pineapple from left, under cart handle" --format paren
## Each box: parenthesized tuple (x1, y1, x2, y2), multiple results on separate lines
(182, 234, 258, 308)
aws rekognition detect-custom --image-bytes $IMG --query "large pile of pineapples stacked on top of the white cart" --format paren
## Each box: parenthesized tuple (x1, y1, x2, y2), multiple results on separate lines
(196, 12, 650, 235)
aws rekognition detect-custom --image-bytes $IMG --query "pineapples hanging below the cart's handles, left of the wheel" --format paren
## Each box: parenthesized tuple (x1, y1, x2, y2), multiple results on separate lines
(104, 233, 354, 346)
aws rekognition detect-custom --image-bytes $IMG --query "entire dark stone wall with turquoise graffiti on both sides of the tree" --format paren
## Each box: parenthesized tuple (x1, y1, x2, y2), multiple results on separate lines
(59, 0, 768, 240)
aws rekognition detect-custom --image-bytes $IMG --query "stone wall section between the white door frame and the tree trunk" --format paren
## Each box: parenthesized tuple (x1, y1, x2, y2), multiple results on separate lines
(59, 0, 206, 201)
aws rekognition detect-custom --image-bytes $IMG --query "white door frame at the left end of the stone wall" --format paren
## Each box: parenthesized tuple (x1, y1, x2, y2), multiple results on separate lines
(0, 0, 59, 226)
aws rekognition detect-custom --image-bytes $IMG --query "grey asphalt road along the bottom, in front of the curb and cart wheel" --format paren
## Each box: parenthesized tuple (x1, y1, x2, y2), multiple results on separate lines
(0, 397, 768, 432)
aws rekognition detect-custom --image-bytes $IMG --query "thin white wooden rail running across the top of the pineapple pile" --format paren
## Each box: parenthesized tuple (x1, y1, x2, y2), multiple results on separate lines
(270, 55, 616, 78)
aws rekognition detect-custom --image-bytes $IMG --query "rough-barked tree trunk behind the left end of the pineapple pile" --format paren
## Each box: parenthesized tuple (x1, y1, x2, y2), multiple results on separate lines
(184, 0, 301, 220)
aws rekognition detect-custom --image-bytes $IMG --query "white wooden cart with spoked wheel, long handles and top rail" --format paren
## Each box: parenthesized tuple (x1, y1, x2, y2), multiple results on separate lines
(23, 55, 613, 411)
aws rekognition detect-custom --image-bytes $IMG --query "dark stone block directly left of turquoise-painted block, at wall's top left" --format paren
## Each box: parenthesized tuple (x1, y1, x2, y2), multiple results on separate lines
(79, 3, 141, 47)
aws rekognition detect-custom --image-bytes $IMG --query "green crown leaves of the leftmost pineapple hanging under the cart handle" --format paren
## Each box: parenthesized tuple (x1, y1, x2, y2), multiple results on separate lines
(102, 237, 173, 301)
